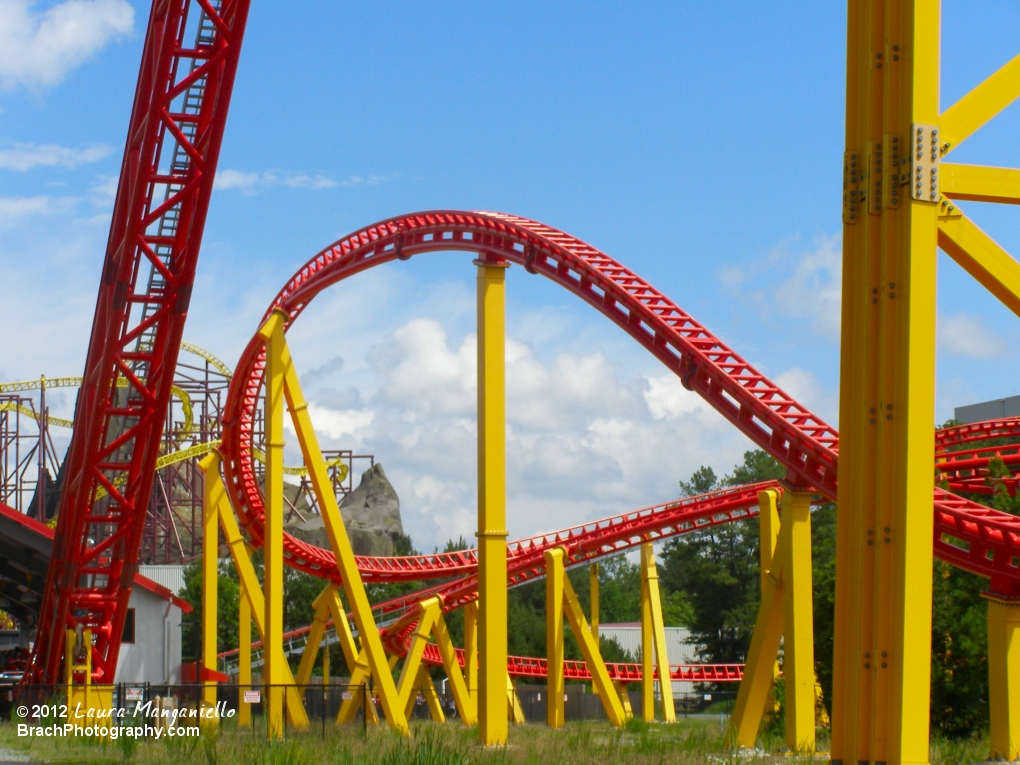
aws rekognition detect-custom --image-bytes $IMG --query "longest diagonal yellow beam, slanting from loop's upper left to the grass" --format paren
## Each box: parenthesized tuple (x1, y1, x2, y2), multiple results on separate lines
(275, 311, 410, 734)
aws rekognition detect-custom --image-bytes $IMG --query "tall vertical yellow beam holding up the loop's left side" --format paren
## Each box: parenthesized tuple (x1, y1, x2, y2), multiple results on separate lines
(259, 312, 290, 740)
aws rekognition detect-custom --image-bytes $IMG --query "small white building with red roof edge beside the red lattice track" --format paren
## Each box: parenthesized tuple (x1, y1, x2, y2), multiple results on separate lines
(114, 566, 192, 684)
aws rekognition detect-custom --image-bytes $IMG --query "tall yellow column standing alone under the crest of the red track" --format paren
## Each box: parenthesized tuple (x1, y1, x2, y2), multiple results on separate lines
(475, 255, 509, 746)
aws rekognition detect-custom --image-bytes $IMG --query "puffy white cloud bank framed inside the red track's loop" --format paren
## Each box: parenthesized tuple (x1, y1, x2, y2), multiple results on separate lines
(294, 317, 749, 550)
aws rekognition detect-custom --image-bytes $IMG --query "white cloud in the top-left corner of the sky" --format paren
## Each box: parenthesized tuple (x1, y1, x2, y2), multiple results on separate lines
(0, 0, 135, 90)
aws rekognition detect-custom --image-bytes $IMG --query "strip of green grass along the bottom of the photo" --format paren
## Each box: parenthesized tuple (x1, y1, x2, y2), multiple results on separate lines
(0, 720, 988, 765)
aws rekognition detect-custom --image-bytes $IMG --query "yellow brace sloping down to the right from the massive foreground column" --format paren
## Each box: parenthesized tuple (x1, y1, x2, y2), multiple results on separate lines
(938, 204, 1020, 316)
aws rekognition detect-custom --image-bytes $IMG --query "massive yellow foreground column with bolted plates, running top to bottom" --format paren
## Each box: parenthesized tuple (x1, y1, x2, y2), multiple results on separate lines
(836, 5, 942, 765)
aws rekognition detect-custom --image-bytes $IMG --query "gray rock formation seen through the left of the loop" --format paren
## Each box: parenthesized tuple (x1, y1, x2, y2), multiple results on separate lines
(287, 462, 404, 556)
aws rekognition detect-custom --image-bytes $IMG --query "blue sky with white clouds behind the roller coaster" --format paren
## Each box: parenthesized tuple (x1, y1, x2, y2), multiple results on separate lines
(0, 0, 1020, 548)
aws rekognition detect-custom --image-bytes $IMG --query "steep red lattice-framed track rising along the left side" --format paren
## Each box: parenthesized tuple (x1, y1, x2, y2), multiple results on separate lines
(28, 0, 249, 682)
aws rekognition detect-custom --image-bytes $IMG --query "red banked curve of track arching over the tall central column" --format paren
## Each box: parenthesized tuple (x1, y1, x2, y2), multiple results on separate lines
(222, 211, 1020, 595)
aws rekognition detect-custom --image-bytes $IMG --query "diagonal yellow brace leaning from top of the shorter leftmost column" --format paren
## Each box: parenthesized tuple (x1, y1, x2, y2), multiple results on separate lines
(198, 450, 308, 729)
